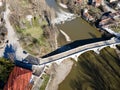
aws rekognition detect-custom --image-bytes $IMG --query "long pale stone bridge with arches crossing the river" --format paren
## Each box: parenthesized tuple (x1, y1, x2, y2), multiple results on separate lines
(39, 38, 120, 65)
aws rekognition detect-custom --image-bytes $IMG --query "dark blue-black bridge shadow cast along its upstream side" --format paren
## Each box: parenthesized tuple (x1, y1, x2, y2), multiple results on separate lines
(42, 36, 113, 58)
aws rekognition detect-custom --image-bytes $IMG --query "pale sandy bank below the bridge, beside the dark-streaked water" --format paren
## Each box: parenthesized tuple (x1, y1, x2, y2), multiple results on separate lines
(46, 59, 73, 90)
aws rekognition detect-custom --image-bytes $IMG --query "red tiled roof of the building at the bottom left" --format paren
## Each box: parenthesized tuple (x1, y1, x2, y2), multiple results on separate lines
(4, 67, 32, 90)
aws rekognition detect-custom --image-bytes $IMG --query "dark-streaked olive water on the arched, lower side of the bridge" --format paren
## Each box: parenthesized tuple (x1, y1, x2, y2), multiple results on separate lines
(59, 47, 120, 90)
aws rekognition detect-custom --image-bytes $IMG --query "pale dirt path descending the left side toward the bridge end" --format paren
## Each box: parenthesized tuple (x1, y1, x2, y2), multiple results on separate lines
(4, 4, 28, 60)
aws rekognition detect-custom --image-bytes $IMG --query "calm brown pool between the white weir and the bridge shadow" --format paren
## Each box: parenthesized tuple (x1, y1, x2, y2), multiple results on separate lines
(58, 17, 101, 45)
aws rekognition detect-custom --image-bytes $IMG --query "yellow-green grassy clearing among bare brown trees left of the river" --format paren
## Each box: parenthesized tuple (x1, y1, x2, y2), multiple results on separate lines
(16, 17, 49, 55)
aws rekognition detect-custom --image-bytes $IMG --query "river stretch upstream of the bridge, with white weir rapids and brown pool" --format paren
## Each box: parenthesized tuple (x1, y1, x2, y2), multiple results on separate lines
(46, 0, 101, 46)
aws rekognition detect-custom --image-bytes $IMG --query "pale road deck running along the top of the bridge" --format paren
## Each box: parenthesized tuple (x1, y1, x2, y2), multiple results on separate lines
(40, 38, 120, 64)
